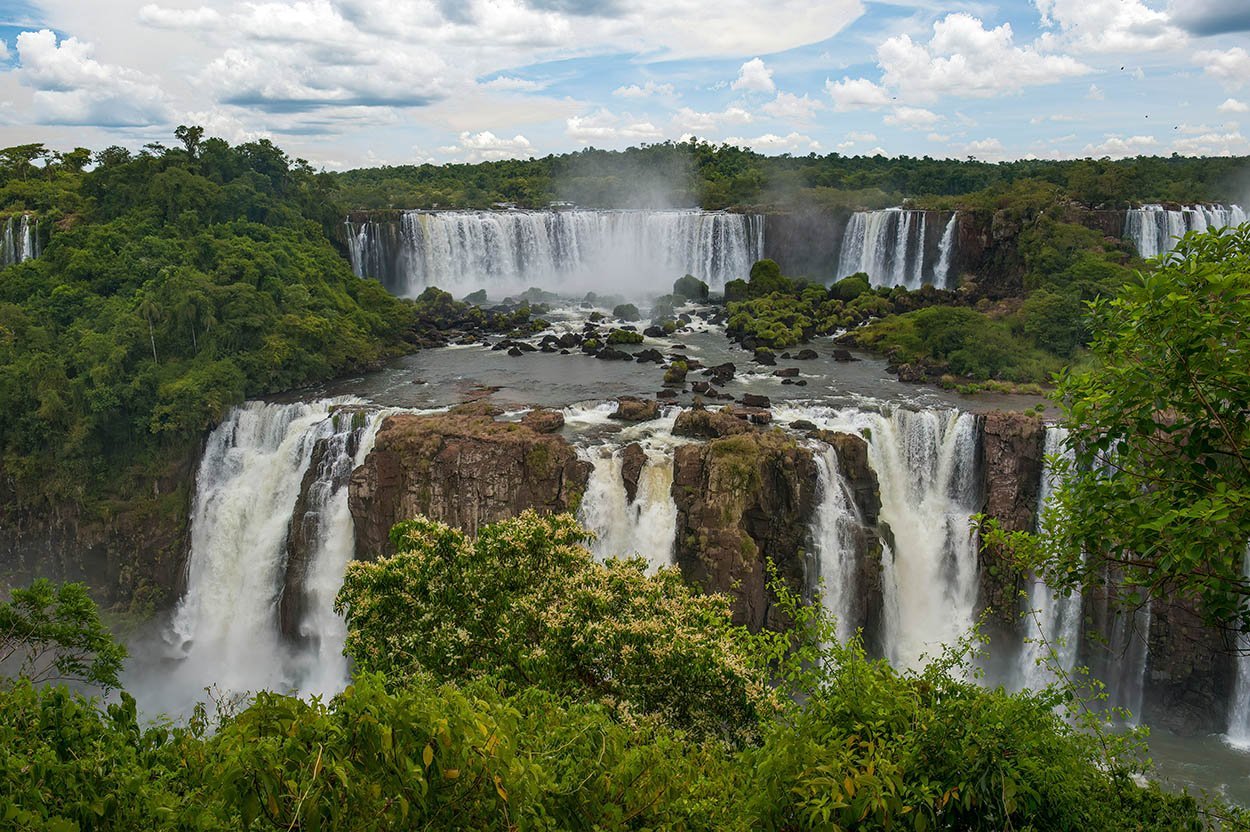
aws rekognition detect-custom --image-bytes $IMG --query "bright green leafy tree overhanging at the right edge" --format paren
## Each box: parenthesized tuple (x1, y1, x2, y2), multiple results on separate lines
(1045, 225, 1250, 631)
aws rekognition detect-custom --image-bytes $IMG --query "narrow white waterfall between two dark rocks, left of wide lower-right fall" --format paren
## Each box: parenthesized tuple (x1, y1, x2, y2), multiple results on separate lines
(813, 446, 864, 641)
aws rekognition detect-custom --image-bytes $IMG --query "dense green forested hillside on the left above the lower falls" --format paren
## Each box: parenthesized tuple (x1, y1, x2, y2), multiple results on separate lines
(0, 133, 522, 507)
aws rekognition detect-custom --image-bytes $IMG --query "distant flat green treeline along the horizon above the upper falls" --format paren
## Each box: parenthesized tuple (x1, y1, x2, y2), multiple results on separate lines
(325, 139, 1250, 210)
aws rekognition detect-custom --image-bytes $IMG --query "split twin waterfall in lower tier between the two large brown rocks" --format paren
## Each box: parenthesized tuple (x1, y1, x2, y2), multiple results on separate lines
(579, 445, 678, 571)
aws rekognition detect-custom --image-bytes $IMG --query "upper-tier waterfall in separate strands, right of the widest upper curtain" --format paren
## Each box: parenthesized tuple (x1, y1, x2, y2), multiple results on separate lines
(838, 209, 956, 289)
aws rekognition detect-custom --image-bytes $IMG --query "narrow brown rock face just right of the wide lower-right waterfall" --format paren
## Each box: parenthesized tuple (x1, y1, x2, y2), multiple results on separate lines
(980, 411, 1046, 624)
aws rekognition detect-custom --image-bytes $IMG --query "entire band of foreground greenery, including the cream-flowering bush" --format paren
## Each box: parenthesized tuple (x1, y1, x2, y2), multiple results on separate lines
(0, 512, 1248, 832)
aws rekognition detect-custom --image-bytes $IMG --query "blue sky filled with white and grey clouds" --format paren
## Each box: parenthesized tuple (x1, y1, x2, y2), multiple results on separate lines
(0, 0, 1250, 170)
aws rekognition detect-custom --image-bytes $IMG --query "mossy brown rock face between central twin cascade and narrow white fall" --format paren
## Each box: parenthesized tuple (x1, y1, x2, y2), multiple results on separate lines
(673, 427, 816, 631)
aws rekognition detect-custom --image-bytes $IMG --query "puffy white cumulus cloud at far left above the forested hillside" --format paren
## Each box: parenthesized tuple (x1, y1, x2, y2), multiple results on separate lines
(18, 29, 166, 127)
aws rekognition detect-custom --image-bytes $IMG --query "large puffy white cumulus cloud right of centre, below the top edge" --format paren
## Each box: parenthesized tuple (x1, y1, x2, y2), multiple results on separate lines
(876, 12, 1093, 101)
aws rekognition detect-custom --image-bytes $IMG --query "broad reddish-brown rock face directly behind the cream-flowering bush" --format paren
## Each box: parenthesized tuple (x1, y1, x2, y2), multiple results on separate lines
(348, 405, 591, 558)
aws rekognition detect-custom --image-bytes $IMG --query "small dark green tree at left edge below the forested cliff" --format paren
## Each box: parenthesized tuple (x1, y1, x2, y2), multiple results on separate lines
(0, 580, 126, 690)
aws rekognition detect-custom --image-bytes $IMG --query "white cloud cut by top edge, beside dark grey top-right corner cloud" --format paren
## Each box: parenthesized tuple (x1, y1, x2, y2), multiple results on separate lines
(1034, 0, 1186, 54)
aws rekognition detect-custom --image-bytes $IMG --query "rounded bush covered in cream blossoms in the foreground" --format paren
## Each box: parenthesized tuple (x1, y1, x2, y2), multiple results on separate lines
(339, 512, 774, 741)
